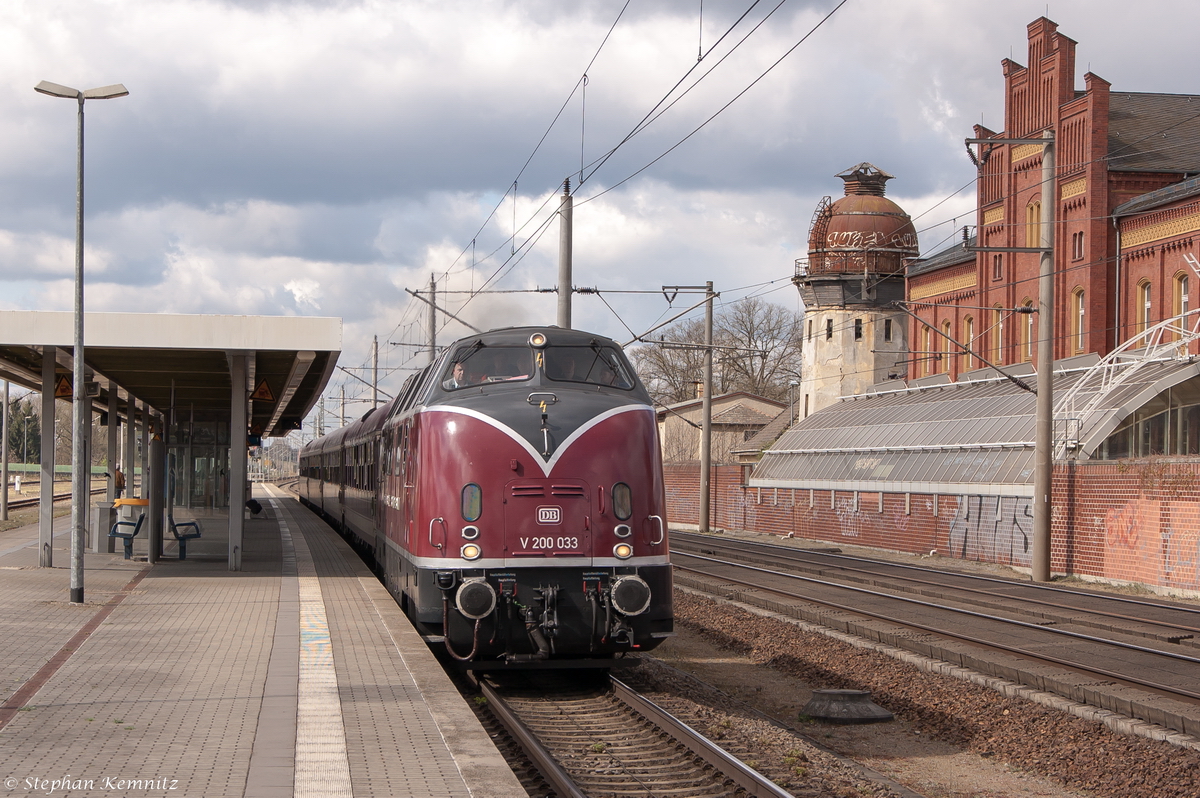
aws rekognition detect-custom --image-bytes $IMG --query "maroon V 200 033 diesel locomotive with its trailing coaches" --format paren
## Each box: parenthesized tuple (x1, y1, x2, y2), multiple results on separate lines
(299, 328, 673, 668)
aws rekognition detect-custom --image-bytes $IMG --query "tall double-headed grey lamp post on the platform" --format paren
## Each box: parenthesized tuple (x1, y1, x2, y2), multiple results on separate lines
(34, 80, 130, 604)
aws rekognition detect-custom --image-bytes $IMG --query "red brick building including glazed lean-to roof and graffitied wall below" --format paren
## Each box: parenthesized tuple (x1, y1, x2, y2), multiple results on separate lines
(667, 18, 1200, 593)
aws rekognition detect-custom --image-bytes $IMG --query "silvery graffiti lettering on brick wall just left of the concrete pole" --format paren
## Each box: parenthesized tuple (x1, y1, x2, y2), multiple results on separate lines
(950, 496, 1033, 565)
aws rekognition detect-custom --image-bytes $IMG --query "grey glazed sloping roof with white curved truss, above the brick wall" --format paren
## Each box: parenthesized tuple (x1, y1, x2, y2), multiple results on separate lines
(750, 352, 1200, 496)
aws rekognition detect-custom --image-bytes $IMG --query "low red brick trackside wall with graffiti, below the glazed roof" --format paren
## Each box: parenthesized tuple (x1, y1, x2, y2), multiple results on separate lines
(665, 458, 1200, 590)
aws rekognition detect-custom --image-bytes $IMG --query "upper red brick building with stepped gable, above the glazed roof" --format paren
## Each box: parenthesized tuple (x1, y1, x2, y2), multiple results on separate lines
(907, 18, 1200, 379)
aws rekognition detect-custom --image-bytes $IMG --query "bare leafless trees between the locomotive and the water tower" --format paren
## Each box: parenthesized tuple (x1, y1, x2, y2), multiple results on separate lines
(630, 296, 803, 404)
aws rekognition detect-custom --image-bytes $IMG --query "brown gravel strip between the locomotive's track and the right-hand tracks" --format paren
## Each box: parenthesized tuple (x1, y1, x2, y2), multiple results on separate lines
(662, 592, 1200, 798)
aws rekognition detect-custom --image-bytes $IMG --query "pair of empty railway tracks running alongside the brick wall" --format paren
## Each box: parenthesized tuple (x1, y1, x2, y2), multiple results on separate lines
(672, 533, 1200, 736)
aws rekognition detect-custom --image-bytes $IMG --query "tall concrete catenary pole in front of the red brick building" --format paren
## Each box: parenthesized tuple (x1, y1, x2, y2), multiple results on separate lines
(1031, 131, 1057, 582)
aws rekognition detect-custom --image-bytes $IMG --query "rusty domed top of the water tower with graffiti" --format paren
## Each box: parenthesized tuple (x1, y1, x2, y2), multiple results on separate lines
(809, 162, 919, 275)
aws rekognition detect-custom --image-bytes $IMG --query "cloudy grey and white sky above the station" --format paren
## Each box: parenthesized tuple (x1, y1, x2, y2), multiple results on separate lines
(0, 0, 1200, 410)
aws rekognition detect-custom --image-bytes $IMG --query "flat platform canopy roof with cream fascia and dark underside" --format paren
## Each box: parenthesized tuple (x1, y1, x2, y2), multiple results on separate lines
(0, 311, 342, 436)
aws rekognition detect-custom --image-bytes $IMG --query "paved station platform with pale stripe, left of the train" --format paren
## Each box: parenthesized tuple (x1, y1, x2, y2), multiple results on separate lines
(0, 485, 524, 798)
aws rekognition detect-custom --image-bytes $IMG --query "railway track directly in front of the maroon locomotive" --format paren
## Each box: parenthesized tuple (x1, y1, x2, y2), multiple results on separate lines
(479, 671, 788, 798)
